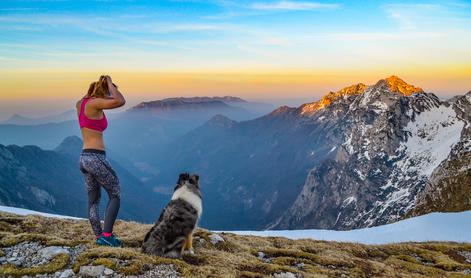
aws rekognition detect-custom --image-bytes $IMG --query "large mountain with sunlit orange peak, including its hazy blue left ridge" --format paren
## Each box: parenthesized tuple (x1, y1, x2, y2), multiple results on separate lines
(153, 76, 470, 230)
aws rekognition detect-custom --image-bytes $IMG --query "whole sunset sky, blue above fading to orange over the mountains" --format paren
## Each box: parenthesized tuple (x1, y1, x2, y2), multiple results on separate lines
(0, 0, 471, 120)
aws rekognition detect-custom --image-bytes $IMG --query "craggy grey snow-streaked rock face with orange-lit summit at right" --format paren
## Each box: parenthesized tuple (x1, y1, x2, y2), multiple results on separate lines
(271, 76, 471, 229)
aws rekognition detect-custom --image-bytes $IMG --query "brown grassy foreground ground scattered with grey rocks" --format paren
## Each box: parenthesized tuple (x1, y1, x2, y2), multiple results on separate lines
(0, 213, 471, 278)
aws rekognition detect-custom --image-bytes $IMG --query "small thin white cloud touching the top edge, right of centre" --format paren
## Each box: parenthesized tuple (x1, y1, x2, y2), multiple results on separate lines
(250, 1, 339, 11)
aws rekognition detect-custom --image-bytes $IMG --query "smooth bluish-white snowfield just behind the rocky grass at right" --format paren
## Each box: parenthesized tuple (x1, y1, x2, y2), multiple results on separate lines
(230, 211, 471, 244)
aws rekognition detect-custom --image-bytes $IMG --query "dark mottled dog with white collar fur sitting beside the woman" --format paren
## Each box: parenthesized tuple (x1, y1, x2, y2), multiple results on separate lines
(142, 173, 203, 258)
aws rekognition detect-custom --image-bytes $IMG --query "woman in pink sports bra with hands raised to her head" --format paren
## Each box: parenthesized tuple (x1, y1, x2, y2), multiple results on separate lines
(77, 76, 126, 247)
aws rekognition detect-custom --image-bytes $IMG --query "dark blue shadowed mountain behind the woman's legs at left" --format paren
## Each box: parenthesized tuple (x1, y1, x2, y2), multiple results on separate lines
(0, 137, 167, 222)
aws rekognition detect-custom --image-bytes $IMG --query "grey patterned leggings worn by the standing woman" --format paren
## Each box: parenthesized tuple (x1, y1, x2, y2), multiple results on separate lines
(80, 149, 120, 236)
